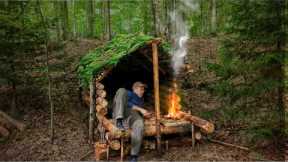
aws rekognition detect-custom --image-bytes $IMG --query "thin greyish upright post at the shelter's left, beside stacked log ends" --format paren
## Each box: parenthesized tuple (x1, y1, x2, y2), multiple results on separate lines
(89, 77, 96, 143)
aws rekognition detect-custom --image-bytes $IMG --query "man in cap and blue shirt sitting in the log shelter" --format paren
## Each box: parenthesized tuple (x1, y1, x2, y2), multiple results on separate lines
(113, 82, 151, 161)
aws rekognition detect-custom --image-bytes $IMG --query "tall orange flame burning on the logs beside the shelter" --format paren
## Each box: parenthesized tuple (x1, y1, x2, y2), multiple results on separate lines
(167, 83, 181, 118)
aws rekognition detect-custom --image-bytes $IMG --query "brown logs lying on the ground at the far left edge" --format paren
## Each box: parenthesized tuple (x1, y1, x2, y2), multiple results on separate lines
(0, 110, 25, 138)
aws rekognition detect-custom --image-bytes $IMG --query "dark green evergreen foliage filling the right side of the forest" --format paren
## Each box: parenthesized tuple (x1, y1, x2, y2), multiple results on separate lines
(207, 0, 287, 142)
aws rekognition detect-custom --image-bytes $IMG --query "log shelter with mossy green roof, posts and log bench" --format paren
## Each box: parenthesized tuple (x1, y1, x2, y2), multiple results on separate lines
(78, 34, 212, 160)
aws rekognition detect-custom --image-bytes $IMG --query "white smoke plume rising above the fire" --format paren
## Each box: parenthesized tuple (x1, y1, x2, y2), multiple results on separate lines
(169, 0, 199, 75)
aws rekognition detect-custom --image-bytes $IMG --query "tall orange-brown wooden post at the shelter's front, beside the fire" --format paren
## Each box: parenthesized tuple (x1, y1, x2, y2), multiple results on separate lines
(152, 42, 161, 153)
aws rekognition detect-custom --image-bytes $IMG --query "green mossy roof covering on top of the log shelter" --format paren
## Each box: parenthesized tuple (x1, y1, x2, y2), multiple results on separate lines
(77, 34, 170, 87)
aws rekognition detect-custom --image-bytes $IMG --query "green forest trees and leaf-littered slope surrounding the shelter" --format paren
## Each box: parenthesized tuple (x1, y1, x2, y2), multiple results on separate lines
(0, 0, 288, 160)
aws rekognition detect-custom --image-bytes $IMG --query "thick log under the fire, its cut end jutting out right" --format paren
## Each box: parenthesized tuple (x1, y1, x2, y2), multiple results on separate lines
(166, 111, 214, 134)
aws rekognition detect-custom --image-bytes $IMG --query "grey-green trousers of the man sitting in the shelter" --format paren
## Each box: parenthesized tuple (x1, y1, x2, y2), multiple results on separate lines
(113, 88, 144, 155)
